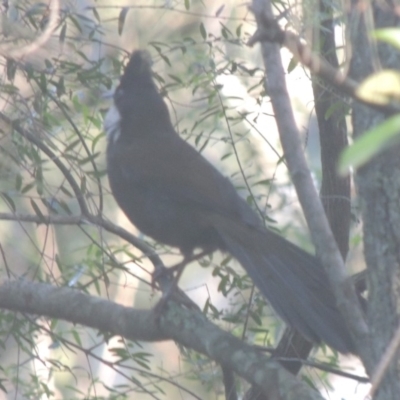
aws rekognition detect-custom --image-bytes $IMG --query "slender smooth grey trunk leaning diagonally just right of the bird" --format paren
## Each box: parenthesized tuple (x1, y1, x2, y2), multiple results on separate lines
(252, 0, 369, 355)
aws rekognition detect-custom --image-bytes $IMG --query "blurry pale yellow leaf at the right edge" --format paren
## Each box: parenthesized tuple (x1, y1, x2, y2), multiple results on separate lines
(356, 69, 400, 105)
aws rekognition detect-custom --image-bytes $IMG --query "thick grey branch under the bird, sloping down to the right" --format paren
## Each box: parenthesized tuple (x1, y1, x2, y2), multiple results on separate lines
(0, 280, 322, 400)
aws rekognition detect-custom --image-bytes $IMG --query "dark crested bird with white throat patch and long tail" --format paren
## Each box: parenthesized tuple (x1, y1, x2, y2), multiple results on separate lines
(104, 50, 356, 354)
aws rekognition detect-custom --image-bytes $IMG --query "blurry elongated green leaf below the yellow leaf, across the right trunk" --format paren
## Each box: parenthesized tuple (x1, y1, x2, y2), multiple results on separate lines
(338, 114, 400, 175)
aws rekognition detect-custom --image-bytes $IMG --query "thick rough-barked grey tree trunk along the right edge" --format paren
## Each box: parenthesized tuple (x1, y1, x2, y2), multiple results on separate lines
(349, 3, 400, 400)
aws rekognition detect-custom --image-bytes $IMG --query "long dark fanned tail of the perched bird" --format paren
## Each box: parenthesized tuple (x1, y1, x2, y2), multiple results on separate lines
(214, 218, 355, 353)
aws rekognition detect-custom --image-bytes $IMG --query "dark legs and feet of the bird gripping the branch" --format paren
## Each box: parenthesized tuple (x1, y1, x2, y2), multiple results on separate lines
(152, 250, 210, 312)
